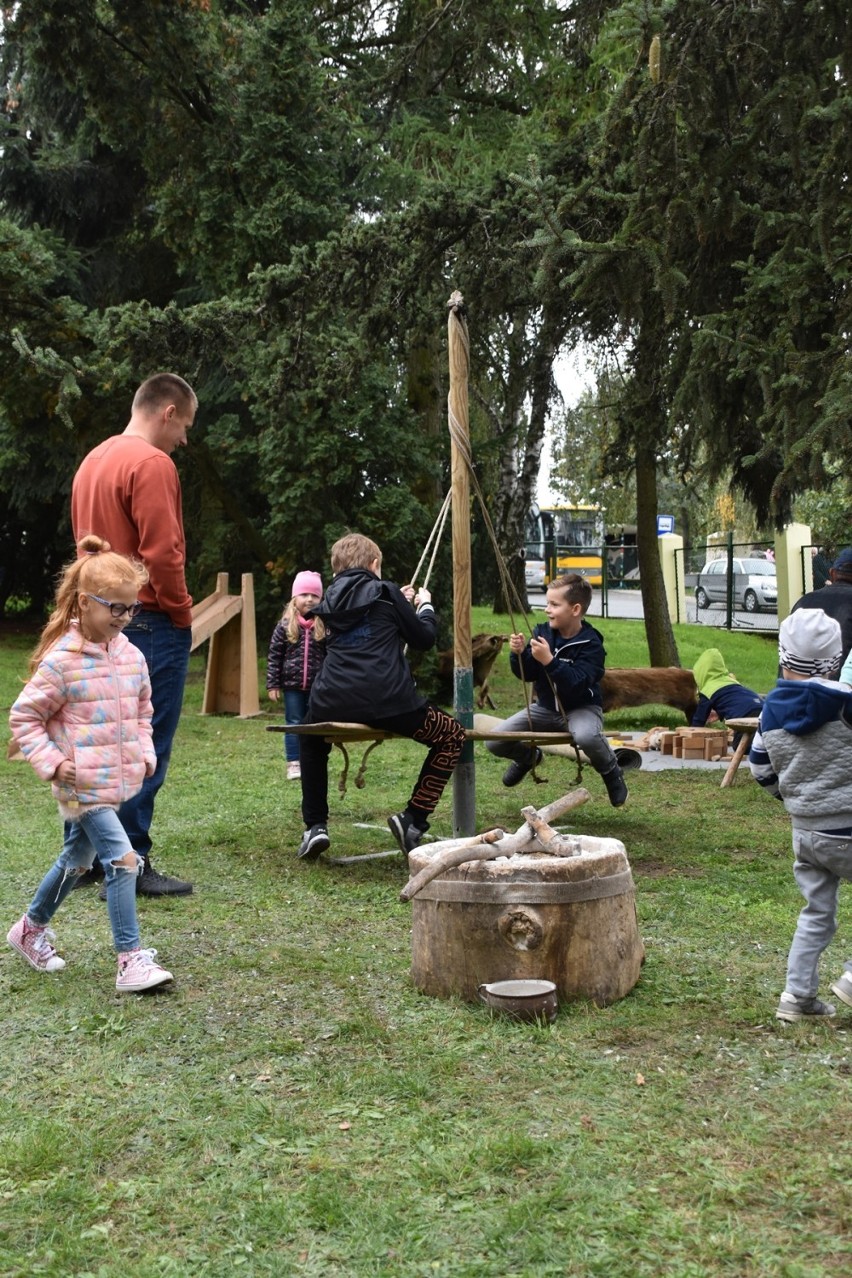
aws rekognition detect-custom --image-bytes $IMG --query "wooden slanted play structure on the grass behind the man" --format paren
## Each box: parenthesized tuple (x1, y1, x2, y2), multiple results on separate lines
(190, 573, 261, 718)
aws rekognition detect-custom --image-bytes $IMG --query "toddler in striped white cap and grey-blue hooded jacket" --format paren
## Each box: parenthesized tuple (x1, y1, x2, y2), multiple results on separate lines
(749, 608, 852, 1021)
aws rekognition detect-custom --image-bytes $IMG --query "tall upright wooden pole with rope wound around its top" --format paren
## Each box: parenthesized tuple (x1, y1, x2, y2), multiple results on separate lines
(447, 291, 476, 836)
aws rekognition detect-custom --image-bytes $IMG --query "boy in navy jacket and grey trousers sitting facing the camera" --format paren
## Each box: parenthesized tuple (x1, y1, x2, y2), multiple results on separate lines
(487, 573, 627, 808)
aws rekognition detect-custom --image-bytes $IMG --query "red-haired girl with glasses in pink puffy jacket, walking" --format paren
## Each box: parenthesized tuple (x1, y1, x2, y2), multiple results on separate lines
(6, 535, 172, 993)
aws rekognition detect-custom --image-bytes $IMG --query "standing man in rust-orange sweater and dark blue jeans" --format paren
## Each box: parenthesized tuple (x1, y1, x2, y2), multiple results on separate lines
(72, 373, 198, 896)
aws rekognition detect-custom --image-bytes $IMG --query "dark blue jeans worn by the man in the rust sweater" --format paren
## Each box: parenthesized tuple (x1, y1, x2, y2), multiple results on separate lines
(119, 610, 192, 860)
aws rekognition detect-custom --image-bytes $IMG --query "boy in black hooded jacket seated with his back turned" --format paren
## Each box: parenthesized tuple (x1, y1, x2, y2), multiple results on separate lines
(298, 533, 465, 860)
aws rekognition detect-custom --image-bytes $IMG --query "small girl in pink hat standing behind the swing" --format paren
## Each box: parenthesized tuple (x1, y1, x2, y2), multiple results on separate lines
(266, 571, 326, 781)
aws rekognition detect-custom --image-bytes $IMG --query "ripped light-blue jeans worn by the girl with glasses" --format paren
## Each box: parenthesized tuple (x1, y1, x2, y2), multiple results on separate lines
(27, 808, 143, 953)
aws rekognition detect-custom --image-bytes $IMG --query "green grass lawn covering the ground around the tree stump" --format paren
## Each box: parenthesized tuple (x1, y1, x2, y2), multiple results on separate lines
(0, 610, 852, 1278)
